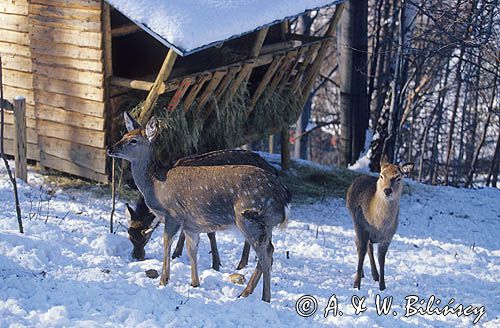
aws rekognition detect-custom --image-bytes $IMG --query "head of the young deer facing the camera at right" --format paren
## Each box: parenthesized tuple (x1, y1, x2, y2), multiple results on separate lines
(377, 156, 413, 200)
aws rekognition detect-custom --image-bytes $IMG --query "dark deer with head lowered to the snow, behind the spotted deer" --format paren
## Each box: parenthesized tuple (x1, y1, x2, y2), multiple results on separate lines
(125, 149, 278, 271)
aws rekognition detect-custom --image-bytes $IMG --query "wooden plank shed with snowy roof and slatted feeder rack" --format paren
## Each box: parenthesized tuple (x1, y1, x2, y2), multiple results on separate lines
(0, 0, 341, 182)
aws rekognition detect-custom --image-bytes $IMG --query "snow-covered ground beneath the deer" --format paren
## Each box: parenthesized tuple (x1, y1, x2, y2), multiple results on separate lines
(0, 163, 500, 327)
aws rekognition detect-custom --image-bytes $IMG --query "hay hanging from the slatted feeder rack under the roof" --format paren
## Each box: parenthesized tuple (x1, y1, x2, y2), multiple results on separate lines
(120, 85, 302, 165)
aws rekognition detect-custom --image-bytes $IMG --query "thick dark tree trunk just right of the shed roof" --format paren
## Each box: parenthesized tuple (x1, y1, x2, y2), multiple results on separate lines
(339, 0, 369, 166)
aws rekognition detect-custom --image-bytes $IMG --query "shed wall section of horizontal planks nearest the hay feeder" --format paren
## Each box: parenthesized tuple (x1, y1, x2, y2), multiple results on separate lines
(28, 0, 108, 182)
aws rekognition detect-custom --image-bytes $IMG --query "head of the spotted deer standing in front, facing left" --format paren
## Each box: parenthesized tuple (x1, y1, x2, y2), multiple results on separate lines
(108, 112, 158, 162)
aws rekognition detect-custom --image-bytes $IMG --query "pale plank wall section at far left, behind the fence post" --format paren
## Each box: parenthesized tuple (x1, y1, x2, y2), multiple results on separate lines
(0, 0, 40, 160)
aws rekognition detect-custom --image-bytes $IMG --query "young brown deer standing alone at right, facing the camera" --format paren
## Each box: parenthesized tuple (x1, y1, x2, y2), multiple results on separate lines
(347, 159, 413, 290)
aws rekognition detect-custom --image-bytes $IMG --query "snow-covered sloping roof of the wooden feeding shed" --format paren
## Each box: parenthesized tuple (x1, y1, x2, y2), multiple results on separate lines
(107, 0, 343, 56)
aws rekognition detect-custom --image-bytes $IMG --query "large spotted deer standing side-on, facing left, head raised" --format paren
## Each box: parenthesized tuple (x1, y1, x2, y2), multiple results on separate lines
(108, 113, 291, 302)
